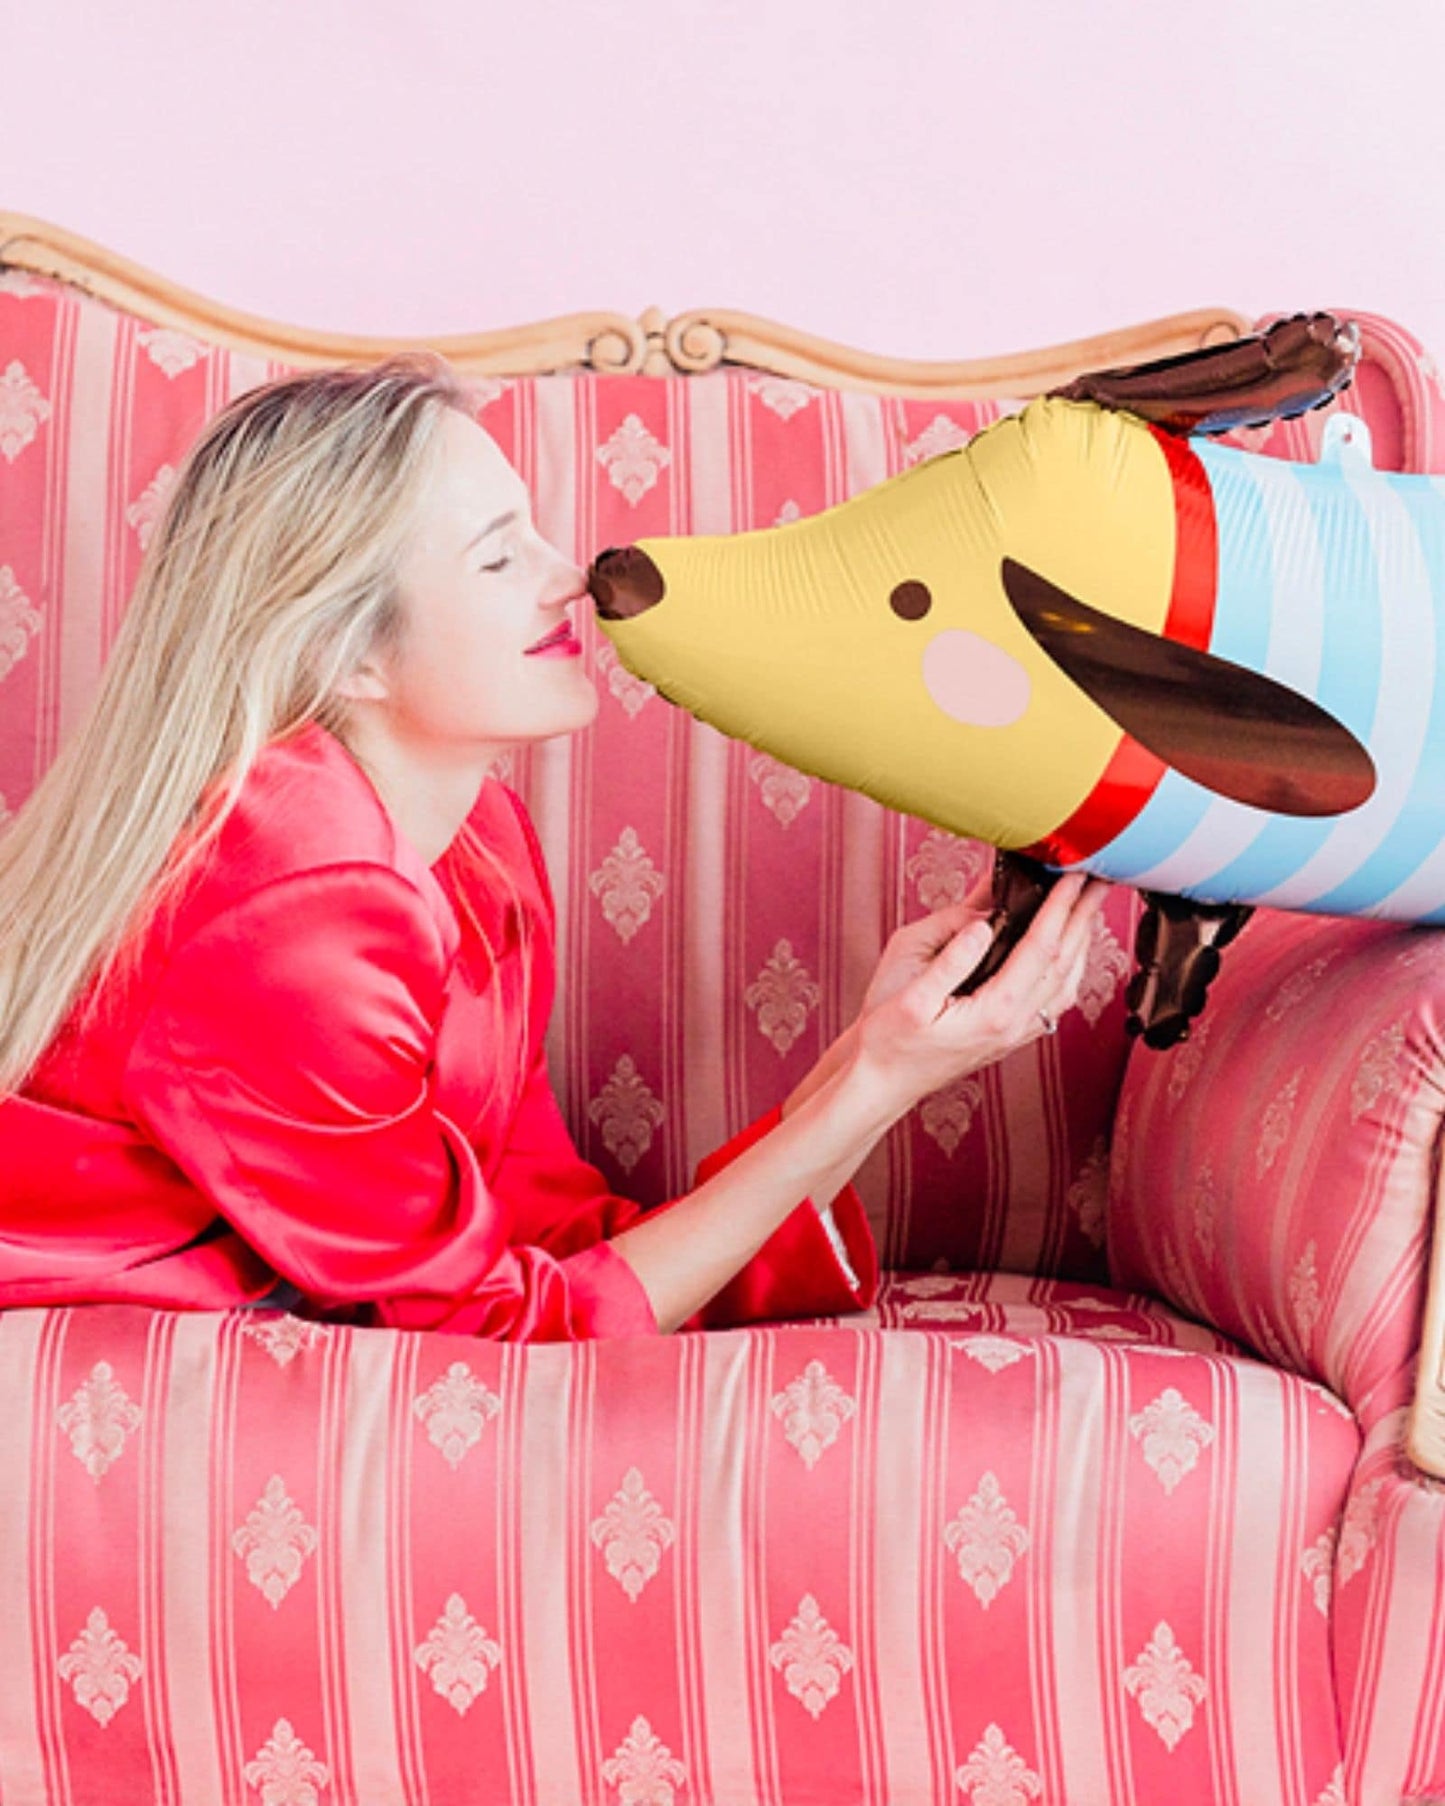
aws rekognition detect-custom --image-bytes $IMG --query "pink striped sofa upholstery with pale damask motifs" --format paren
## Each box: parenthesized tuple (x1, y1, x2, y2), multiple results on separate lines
(0, 232, 1445, 1806)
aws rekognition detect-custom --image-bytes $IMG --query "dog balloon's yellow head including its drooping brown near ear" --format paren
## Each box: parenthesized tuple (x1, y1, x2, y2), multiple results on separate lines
(589, 399, 1373, 849)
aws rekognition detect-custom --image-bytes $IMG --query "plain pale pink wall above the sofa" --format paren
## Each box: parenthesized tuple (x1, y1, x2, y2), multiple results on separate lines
(0, 0, 1445, 356)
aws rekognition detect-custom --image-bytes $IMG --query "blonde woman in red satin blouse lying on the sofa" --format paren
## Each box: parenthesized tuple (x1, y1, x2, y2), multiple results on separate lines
(0, 359, 1100, 1338)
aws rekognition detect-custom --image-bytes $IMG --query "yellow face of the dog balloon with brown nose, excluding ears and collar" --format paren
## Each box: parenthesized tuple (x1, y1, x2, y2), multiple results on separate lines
(591, 401, 1174, 847)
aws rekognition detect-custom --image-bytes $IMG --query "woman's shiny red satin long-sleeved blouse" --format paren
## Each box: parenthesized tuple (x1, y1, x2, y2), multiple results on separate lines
(0, 726, 878, 1340)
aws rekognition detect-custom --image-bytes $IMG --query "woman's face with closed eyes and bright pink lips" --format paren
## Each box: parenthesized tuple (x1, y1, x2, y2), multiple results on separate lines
(370, 408, 598, 762)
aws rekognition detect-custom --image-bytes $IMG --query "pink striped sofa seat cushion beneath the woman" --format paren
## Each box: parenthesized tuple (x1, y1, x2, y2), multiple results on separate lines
(0, 1280, 1358, 1806)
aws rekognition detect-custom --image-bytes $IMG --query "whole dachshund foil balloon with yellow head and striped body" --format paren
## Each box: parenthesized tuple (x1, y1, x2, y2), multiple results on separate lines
(589, 316, 1445, 1046)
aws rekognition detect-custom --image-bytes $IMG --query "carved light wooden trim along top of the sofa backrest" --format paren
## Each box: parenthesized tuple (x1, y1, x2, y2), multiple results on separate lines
(0, 213, 1252, 401)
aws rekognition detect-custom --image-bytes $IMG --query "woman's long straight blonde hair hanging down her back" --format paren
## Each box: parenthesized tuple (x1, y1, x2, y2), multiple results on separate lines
(0, 356, 466, 1096)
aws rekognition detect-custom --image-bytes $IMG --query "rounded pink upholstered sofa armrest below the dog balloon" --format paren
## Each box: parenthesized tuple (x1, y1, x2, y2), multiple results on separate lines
(1107, 910, 1445, 1466)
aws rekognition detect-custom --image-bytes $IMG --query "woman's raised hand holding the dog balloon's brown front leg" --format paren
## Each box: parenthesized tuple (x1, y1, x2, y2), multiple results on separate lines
(851, 872, 1109, 1116)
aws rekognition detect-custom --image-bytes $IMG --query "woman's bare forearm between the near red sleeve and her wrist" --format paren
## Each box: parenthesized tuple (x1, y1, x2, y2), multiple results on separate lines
(612, 1060, 900, 1333)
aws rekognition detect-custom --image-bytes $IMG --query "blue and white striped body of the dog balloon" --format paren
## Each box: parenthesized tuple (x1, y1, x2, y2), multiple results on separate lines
(1084, 441, 1445, 923)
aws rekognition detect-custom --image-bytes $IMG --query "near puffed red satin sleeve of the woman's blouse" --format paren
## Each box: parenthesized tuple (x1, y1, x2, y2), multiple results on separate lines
(126, 865, 657, 1340)
